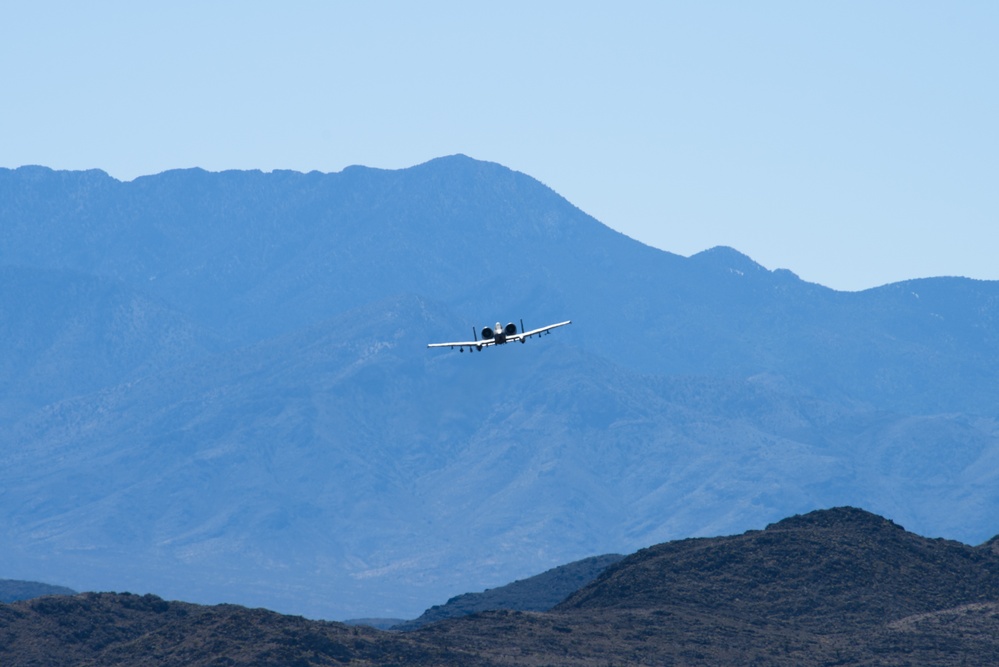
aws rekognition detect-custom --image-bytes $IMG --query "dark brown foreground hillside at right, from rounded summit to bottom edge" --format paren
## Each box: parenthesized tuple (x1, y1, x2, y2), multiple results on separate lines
(415, 508, 999, 665)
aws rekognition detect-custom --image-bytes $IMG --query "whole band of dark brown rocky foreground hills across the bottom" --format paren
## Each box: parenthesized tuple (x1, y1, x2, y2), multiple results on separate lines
(0, 508, 999, 666)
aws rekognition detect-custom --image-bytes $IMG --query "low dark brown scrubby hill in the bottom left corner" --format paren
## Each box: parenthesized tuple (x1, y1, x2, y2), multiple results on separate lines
(0, 593, 491, 667)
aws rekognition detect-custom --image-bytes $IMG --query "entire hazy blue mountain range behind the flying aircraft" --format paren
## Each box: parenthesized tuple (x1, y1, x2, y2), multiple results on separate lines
(0, 156, 999, 618)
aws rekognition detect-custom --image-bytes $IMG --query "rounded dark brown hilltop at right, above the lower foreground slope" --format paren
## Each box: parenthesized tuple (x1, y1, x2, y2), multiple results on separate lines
(557, 507, 999, 630)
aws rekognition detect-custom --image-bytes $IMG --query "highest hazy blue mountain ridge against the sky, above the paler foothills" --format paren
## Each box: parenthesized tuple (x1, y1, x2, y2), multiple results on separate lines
(0, 156, 999, 414)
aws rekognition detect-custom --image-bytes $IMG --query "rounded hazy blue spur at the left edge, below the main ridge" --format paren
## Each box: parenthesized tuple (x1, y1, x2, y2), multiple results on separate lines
(0, 266, 222, 421)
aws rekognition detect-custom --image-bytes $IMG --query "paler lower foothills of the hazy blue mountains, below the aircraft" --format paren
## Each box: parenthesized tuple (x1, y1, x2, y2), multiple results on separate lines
(0, 295, 999, 618)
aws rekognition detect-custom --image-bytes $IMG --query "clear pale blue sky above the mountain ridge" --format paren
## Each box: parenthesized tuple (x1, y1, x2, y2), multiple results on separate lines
(0, 0, 999, 290)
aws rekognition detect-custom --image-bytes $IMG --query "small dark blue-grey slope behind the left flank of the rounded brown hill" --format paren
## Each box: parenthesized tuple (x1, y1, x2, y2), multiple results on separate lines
(392, 554, 624, 630)
